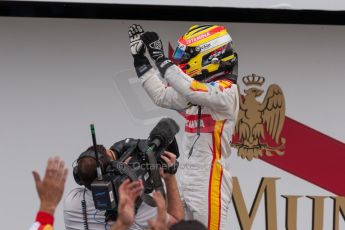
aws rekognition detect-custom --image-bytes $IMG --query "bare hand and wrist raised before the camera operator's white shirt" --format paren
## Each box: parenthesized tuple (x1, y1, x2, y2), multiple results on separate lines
(112, 179, 143, 230)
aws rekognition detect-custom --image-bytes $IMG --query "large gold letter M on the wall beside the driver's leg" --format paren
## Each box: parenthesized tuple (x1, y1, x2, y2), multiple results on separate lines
(232, 177, 279, 230)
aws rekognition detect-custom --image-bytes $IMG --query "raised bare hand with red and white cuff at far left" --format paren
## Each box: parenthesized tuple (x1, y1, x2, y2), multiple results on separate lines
(30, 157, 67, 230)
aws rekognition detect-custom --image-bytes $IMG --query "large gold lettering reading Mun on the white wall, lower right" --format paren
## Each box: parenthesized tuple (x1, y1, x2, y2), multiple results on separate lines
(232, 177, 345, 230)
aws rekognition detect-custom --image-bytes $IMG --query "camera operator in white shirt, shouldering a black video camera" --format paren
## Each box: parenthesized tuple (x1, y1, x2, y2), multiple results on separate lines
(64, 139, 184, 230)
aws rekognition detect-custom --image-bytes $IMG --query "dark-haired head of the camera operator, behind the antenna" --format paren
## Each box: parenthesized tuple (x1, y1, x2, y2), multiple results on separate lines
(78, 145, 110, 189)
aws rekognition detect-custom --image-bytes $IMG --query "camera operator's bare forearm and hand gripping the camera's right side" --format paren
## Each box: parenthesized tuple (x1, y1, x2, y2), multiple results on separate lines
(161, 151, 185, 226)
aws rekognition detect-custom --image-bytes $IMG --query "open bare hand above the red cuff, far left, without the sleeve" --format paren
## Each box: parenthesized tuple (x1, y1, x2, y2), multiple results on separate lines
(32, 157, 67, 215)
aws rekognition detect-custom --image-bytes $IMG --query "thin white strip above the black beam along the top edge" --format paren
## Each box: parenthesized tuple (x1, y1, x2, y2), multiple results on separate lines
(16, 0, 345, 10)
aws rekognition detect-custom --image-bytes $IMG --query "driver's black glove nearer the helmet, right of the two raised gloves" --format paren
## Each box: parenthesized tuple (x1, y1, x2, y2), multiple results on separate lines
(141, 32, 174, 77)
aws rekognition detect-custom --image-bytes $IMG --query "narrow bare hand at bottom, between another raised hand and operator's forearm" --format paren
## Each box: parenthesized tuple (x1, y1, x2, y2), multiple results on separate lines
(148, 191, 168, 230)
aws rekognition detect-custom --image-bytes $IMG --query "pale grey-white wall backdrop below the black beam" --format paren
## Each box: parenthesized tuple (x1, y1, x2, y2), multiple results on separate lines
(0, 17, 345, 230)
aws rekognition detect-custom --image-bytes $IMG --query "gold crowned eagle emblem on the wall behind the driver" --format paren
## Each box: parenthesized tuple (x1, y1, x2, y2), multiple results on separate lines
(232, 74, 285, 160)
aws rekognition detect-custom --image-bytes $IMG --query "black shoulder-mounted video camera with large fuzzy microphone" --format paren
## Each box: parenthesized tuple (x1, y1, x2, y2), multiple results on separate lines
(91, 118, 179, 215)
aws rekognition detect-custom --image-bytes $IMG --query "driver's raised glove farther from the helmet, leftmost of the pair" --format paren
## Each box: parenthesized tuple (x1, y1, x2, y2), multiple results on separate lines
(128, 24, 152, 78)
